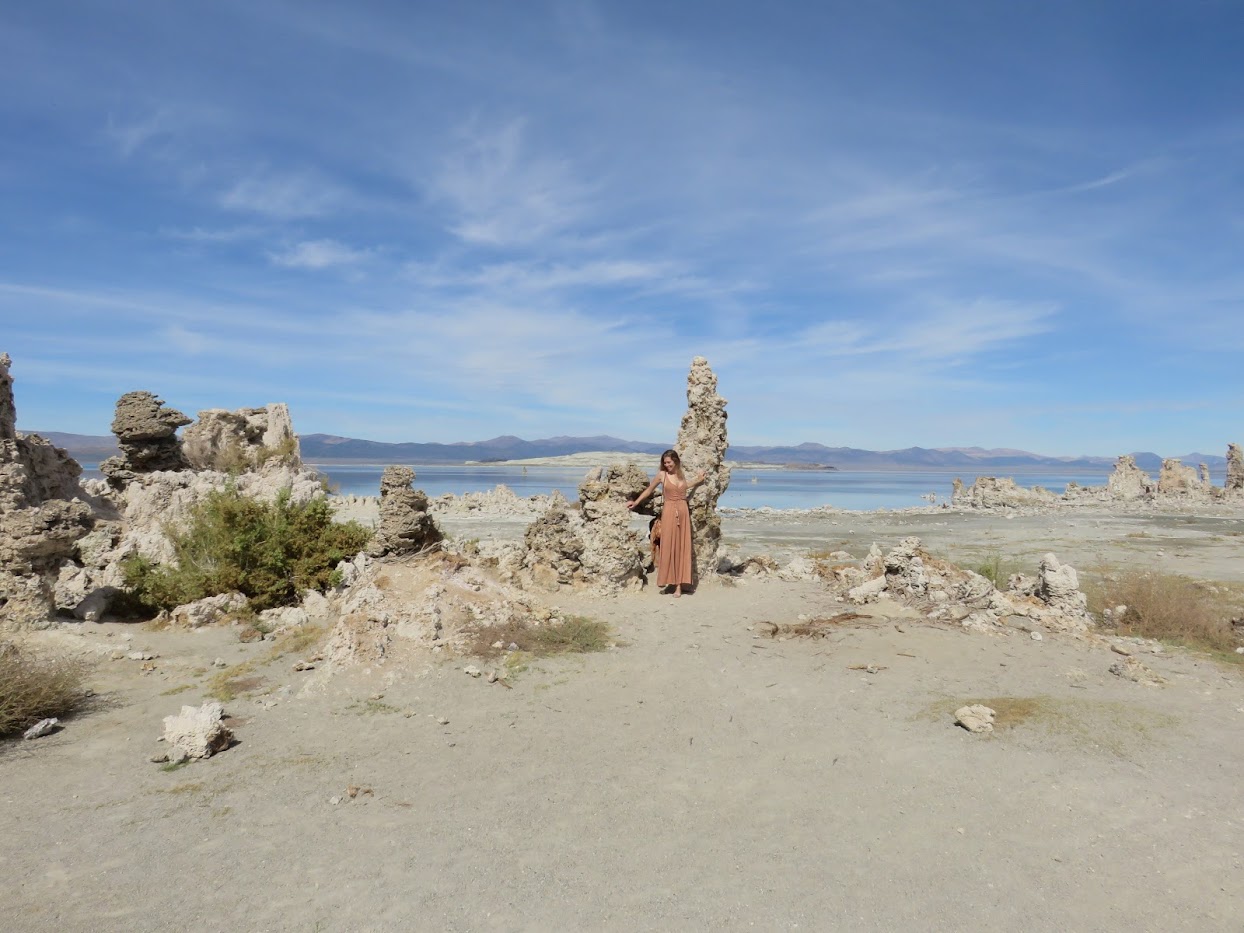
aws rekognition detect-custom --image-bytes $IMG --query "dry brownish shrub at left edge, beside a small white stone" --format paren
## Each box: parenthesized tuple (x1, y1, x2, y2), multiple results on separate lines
(0, 642, 91, 738)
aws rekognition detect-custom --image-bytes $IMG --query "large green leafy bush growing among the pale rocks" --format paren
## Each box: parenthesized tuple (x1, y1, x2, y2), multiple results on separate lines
(123, 486, 371, 611)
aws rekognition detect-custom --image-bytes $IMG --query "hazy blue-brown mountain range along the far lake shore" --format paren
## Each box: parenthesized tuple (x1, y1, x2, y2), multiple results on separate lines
(31, 430, 1227, 475)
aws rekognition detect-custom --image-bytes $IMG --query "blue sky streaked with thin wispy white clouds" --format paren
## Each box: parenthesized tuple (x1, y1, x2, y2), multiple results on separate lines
(0, 0, 1244, 455)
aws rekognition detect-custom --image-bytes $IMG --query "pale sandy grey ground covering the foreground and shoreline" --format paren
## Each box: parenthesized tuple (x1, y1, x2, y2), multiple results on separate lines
(0, 511, 1244, 932)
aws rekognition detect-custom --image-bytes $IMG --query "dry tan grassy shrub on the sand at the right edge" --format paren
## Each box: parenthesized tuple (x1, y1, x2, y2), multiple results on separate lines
(1091, 571, 1239, 651)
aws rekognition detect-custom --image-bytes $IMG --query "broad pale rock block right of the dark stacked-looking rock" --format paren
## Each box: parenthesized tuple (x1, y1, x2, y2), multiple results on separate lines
(182, 402, 302, 473)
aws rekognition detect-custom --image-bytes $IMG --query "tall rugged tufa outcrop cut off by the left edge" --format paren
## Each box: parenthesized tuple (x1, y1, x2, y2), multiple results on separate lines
(0, 353, 95, 628)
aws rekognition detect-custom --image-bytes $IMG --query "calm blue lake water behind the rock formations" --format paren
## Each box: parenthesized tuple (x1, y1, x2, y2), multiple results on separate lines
(82, 463, 1223, 511)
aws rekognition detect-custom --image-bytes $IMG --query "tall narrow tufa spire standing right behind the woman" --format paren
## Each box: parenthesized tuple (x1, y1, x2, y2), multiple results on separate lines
(674, 356, 730, 582)
